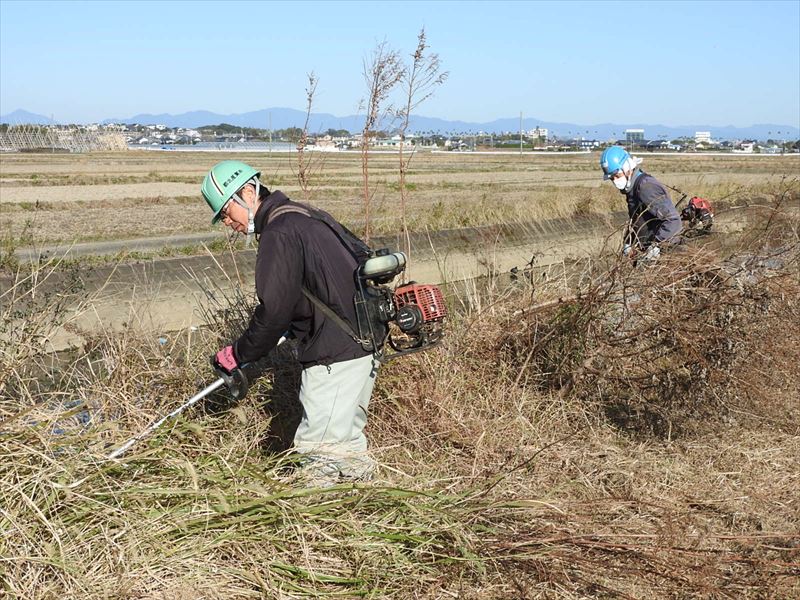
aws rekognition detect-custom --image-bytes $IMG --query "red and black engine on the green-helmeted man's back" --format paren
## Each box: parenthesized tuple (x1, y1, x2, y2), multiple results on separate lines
(355, 249, 447, 360)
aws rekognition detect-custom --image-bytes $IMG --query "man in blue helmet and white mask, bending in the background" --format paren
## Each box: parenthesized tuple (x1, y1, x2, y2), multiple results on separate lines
(600, 146, 683, 260)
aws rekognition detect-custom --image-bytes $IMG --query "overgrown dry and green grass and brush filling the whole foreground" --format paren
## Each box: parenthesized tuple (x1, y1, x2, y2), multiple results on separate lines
(0, 197, 800, 599)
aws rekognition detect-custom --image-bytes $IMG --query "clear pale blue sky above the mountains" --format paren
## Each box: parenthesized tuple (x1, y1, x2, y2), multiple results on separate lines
(0, 0, 800, 127)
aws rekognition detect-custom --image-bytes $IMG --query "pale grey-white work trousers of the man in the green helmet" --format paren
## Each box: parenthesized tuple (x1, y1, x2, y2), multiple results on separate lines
(294, 355, 378, 478)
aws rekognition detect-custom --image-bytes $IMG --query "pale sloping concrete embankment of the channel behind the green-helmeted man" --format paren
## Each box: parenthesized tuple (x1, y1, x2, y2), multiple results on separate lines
(0, 213, 756, 351)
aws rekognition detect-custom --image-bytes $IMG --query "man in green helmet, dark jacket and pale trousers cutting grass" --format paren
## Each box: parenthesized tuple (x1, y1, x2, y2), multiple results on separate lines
(201, 160, 378, 485)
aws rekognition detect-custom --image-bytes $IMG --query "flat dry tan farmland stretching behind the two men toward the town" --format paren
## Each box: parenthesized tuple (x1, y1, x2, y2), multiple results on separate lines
(0, 151, 800, 247)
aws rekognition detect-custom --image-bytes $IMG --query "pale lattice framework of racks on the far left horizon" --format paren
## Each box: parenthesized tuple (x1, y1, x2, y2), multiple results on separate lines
(0, 125, 127, 152)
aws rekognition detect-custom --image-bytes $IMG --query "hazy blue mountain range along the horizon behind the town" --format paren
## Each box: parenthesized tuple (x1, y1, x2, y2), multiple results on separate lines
(0, 108, 800, 140)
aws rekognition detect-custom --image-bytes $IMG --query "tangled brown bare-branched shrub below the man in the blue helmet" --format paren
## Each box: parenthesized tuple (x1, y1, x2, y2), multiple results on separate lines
(498, 196, 800, 439)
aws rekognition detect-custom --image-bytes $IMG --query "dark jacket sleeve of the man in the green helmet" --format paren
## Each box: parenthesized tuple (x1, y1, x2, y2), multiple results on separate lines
(234, 232, 303, 364)
